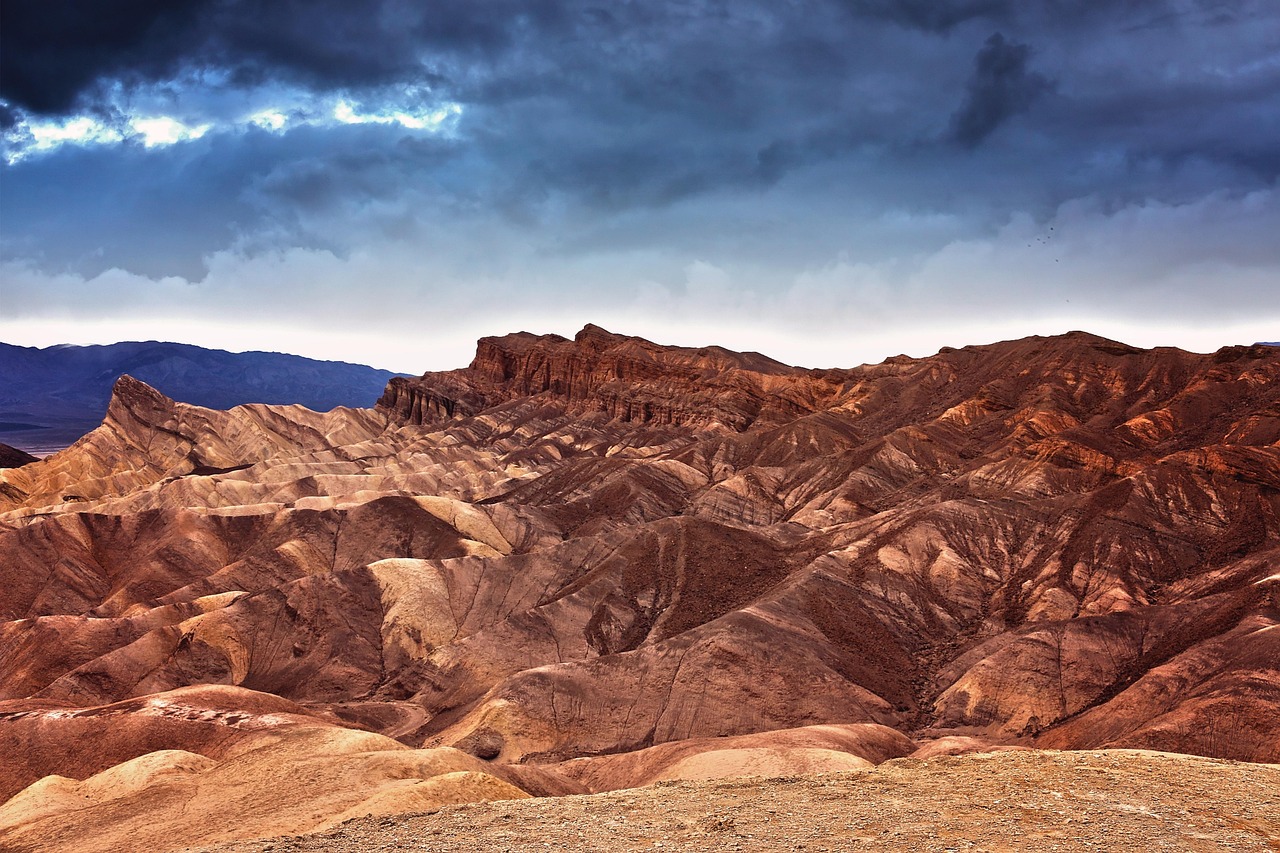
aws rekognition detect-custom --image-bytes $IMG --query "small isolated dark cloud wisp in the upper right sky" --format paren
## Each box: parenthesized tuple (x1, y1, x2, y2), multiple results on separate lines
(951, 32, 1051, 147)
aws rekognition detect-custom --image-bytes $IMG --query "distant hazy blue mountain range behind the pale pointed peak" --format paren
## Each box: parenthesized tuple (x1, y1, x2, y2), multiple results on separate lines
(0, 341, 401, 453)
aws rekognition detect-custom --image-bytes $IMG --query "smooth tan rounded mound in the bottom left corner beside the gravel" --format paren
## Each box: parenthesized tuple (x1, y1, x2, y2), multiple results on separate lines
(0, 726, 529, 853)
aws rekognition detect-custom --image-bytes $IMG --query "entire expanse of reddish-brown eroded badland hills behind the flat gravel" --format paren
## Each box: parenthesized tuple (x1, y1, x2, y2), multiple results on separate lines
(0, 327, 1280, 850)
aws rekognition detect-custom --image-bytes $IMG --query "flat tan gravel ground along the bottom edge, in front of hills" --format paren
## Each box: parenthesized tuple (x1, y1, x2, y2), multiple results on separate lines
(198, 751, 1280, 853)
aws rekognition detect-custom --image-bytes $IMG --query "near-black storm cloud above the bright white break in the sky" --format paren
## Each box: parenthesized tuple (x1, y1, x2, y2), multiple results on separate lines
(0, 0, 563, 114)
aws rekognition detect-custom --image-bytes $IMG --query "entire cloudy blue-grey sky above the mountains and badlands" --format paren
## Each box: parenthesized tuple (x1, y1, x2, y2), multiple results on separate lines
(0, 0, 1280, 373)
